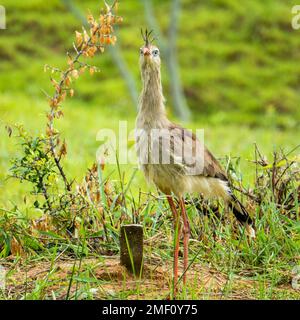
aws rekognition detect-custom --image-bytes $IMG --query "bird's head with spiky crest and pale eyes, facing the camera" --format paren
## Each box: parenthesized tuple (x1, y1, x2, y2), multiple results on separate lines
(140, 29, 160, 70)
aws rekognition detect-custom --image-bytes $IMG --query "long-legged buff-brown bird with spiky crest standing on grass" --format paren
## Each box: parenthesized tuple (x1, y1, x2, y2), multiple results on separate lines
(135, 29, 255, 293)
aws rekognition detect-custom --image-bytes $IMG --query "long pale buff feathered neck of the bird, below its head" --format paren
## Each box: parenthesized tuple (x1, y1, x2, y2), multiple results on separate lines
(138, 67, 166, 123)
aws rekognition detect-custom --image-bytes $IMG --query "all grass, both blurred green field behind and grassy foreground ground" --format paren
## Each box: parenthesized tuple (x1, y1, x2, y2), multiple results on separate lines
(0, 0, 300, 299)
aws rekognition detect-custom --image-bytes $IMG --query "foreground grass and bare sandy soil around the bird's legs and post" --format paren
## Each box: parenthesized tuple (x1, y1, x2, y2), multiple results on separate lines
(1, 182, 300, 299)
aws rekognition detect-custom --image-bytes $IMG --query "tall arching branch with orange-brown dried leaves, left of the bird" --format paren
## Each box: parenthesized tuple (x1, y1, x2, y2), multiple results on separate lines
(45, 1, 122, 191)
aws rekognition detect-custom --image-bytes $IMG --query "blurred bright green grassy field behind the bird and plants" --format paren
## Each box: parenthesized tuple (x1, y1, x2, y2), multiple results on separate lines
(0, 0, 300, 207)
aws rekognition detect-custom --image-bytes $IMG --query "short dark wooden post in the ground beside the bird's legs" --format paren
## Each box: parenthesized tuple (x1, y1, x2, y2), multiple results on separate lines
(120, 224, 143, 276)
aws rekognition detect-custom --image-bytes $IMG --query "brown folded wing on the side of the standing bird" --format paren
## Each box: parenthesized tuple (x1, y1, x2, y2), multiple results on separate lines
(169, 123, 228, 181)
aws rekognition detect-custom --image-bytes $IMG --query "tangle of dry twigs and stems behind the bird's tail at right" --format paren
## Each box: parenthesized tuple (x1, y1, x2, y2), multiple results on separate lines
(227, 144, 300, 219)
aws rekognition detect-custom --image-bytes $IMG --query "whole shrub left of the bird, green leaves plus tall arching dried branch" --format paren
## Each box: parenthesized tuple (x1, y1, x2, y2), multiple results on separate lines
(0, 1, 122, 255)
